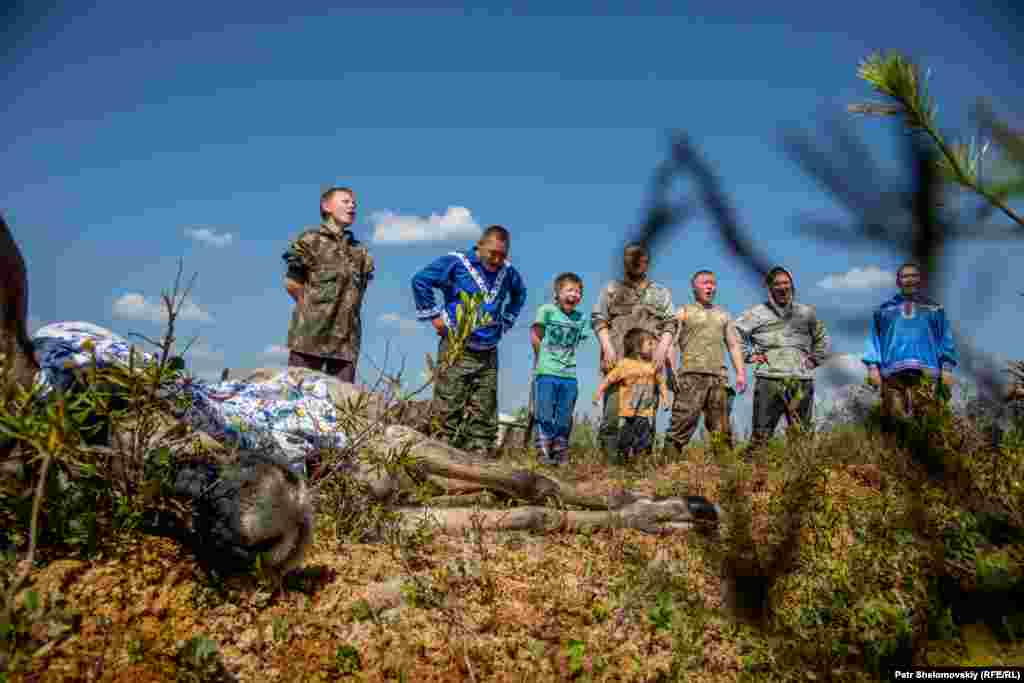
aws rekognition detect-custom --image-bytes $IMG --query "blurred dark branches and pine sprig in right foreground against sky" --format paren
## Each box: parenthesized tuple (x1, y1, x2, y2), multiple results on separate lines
(630, 55, 1024, 403)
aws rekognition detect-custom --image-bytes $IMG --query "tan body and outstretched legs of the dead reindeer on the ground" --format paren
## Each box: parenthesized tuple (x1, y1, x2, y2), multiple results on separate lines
(224, 368, 722, 533)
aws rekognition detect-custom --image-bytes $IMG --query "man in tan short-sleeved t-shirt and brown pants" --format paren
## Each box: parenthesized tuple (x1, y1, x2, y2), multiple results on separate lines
(666, 270, 746, 456)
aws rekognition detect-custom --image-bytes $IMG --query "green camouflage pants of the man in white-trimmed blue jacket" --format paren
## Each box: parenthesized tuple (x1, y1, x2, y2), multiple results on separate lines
(434, 338, 498, 453)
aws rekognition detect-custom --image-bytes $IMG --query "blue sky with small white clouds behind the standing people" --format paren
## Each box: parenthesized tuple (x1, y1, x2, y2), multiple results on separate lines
(8, 0, 1024, 427)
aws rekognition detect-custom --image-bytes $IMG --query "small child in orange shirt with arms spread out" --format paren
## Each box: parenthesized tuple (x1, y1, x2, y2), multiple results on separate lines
(594, 328, 672, 464)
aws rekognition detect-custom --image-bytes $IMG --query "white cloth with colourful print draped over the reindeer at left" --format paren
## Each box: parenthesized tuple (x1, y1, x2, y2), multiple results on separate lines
(33, 323, 346, 474)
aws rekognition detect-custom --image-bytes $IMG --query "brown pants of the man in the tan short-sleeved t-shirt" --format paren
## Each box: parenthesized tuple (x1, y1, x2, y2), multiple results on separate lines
(667, 373, 732, 451)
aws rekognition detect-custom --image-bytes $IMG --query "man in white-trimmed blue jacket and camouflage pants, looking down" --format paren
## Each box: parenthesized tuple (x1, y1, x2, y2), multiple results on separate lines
(413, 225, 526, 455)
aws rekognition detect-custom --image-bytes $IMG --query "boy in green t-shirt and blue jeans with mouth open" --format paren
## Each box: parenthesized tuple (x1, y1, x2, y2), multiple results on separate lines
(529, 272, 592, 465)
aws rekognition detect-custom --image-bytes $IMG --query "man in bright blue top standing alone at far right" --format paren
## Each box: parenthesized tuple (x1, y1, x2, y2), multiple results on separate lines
(863, 263, 957, 428)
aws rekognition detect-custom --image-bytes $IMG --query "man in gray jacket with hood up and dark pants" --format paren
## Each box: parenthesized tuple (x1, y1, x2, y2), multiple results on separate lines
(736, 266, 829, 451)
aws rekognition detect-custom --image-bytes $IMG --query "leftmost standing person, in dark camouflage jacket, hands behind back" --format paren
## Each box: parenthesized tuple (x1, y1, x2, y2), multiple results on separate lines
(282, 187, 374, 382)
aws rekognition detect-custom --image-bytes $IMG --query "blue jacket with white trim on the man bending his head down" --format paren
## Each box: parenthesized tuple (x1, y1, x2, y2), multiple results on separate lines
(413, 248, 526, 350)
